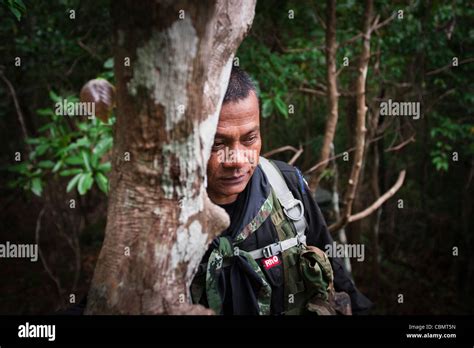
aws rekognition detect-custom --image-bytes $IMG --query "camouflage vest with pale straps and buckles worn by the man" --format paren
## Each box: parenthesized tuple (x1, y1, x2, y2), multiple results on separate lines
(191, 157, 350, 315)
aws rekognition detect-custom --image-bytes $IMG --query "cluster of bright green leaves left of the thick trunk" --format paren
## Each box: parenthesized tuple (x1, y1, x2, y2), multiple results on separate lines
(8, 91, 115, 196)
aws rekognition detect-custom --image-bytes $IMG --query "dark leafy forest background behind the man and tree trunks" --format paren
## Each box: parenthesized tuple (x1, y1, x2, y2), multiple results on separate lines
(0, 0, 474, 314)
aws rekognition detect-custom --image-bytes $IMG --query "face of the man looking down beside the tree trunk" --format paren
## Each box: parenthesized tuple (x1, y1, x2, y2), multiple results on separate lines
(207, 91, 262, 205)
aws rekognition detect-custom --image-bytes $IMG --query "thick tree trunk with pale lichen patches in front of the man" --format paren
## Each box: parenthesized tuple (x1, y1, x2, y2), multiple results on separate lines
(86, 0, 255, 314)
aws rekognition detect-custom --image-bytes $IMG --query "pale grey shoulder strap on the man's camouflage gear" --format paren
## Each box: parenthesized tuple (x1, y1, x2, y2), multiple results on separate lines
(260, 157, 307, 244)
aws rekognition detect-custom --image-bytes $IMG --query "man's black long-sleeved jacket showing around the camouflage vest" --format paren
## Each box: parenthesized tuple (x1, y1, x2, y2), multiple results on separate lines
(194, 161, 372, 315)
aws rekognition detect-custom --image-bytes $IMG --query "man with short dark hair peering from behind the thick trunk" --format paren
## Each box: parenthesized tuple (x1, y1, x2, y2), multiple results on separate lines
(191, 67, 372, 314)
